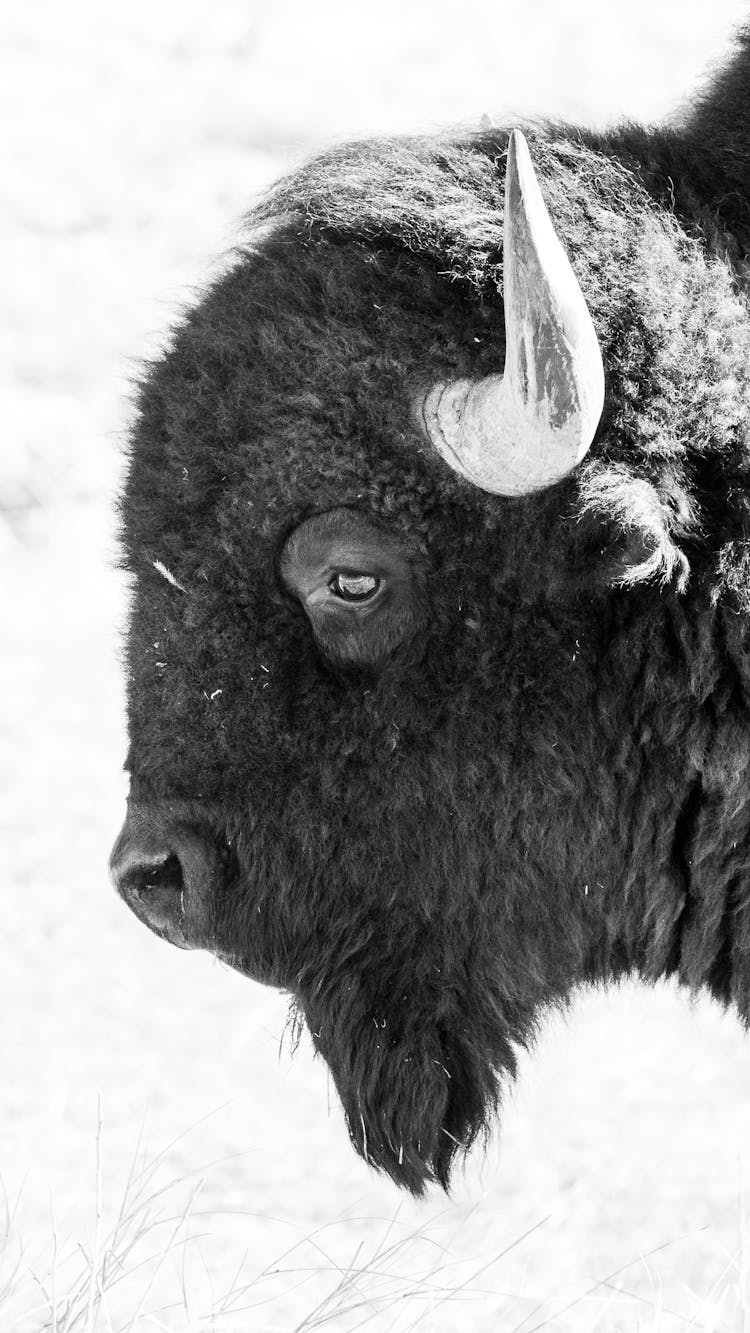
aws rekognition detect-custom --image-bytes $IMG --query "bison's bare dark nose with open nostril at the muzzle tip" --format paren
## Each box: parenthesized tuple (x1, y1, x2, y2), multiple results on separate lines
(109, 813, 220, 949)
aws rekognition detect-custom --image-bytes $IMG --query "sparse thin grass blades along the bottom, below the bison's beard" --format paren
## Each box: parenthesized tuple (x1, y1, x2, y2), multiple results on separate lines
(0, 1105, 750, 1333)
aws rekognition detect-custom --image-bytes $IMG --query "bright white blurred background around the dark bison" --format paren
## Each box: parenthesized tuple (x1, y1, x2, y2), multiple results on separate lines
(0, 0, 750, 1333)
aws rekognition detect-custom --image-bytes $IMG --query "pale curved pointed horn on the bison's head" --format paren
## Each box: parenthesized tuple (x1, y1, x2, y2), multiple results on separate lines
(420, 129, 605, 496)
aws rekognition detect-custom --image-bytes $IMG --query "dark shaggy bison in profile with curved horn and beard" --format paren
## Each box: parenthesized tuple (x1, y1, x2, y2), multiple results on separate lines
(111, 28, 750, 1193)
